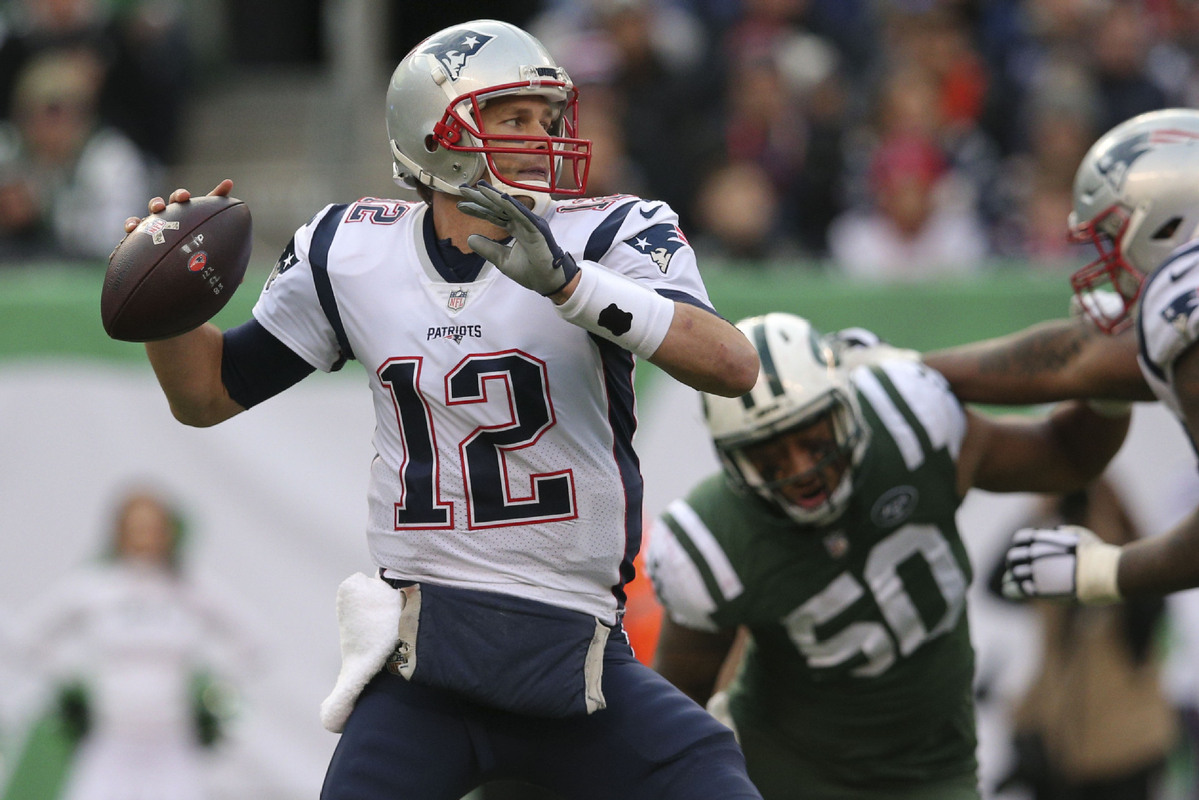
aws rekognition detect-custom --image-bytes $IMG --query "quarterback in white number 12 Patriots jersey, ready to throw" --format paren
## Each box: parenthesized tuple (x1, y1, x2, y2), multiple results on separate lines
(126, 20, 759, 800)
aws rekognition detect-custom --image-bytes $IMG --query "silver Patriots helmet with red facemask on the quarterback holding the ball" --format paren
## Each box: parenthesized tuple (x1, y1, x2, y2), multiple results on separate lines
(387, 19, 591, 211)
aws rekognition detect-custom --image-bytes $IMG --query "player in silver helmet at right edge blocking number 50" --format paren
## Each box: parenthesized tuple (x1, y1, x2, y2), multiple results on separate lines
(924, 109, 1199, 602)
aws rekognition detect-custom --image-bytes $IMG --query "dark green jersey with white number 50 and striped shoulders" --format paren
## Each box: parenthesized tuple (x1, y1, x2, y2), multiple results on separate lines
(647, 362, 977, 798)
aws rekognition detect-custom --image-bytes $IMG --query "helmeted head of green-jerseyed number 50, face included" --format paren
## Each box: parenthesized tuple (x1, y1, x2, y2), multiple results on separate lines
(703, 313, 869, 525)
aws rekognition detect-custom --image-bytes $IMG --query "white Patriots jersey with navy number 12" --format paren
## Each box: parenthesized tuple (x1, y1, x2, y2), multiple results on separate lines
(254, 196, 711, 624)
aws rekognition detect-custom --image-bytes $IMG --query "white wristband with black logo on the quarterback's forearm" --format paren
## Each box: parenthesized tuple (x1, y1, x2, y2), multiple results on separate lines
(558, 264, 674, 359)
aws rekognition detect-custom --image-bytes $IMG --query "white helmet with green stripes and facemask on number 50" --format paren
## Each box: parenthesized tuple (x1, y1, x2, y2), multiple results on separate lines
(700, 313, 869, 524)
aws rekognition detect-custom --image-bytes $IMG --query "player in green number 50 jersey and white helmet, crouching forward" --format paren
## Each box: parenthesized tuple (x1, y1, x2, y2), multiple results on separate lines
(647, 313, 1128, 800)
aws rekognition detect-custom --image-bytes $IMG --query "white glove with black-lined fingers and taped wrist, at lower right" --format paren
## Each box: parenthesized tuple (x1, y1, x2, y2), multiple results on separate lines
(1004, 525, 1121, 603)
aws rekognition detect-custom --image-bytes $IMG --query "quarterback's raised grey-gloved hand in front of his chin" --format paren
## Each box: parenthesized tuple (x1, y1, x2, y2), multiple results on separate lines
(458, 181, 579, 295)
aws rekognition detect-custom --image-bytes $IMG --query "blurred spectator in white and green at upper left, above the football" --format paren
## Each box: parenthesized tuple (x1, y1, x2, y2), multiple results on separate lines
(0, 50, 152, 265)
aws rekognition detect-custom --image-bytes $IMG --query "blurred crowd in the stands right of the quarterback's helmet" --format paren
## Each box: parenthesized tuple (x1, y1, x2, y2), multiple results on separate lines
(531, 0, 1199, 279)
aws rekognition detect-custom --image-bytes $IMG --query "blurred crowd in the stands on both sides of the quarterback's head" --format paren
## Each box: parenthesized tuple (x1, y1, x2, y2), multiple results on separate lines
(0, 0, 1199, 273)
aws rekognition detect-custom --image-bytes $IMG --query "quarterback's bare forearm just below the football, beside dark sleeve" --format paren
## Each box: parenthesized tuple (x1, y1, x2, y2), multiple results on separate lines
(145, 323, 245, 428)
